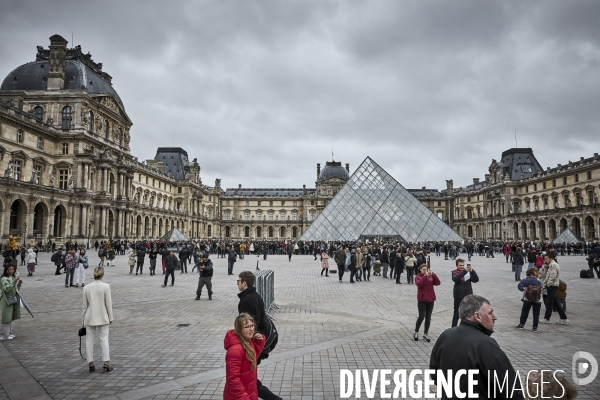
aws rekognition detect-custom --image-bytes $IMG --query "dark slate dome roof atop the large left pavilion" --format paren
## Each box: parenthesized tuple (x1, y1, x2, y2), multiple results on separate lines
(0, 60, 125, 109)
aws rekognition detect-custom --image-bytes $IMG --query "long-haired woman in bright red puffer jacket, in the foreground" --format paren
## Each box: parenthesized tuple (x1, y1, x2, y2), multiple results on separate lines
(223, 313, 265, 400)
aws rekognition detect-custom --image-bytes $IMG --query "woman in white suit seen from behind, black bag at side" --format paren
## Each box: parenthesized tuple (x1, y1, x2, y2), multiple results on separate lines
(83, 267, 113, 372)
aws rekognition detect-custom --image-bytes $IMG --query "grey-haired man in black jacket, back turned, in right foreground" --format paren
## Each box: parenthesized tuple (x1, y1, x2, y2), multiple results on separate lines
(429, 294, 523, 399)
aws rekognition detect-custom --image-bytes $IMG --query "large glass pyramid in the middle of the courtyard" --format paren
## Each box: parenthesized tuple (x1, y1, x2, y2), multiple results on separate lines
(300, 157, 462, 243)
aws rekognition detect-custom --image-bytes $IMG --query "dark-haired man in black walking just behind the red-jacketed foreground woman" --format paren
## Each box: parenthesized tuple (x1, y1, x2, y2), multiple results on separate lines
(237, 271, 281, 400)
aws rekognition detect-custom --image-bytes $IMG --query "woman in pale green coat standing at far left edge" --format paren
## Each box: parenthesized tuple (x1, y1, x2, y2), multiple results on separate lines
(0, 264, 23, 340)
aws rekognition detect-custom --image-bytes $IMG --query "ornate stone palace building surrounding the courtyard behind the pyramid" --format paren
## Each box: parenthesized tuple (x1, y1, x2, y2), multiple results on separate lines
(0, 35, 600, 243)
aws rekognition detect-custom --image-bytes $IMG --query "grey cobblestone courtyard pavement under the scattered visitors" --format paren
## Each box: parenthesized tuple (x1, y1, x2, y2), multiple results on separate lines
(0, 251, 600, 399)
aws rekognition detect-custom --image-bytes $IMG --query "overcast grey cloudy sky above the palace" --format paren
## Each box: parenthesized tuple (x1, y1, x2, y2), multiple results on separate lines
(0, 0, 600, 189)
